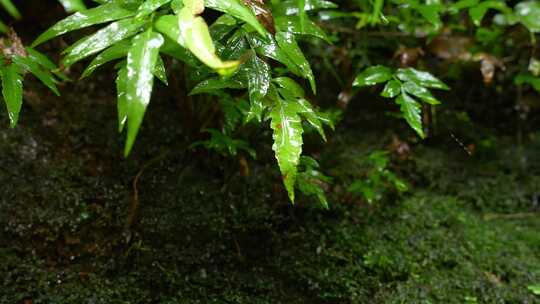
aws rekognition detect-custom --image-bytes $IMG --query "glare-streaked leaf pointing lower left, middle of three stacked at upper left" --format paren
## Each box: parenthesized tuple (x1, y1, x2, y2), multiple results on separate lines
(62, 19, 146, 66)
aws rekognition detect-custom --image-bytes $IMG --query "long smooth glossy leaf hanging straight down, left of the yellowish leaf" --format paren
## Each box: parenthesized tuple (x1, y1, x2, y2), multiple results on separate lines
(124, 29, 163, 156)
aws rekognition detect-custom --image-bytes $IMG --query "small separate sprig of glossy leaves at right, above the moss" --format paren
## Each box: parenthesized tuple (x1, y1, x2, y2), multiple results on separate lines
(353, 65, 449, 138)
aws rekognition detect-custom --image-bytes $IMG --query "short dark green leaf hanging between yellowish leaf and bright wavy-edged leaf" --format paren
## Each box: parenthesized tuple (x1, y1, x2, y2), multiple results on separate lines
(243, 54, 272, 122)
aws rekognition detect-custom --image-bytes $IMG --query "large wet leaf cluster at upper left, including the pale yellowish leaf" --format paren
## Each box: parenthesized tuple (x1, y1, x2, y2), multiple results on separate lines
(0, 0, 336, 205)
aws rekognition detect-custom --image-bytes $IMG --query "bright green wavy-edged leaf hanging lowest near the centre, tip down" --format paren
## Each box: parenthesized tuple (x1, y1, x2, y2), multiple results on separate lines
(270, 98, 303, 203)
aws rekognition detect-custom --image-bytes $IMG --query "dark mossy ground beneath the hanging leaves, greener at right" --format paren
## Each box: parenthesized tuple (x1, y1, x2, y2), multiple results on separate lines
(0, 76, 540, 303)
